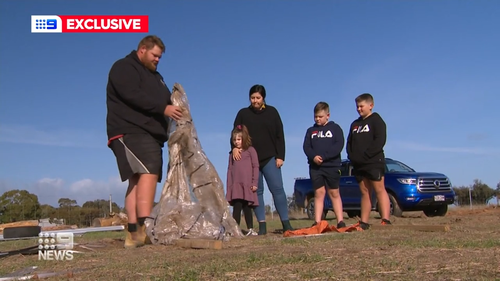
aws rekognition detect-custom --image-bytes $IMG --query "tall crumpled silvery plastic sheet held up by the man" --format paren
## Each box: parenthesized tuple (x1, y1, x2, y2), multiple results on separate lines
(145, 83, 244, 245)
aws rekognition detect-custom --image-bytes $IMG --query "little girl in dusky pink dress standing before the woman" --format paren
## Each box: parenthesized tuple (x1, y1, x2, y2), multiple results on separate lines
(226, 125, 259, 235)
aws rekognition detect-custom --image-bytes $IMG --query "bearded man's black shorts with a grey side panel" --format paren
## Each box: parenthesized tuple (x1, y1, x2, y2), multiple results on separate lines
(109, 134, 163, 182)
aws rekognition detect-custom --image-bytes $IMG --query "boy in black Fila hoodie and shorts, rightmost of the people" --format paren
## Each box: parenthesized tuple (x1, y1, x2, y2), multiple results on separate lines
(347, 93, 391, 229)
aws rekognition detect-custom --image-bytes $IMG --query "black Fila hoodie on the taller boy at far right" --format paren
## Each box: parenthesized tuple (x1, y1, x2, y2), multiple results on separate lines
(347, 113, 387, 168)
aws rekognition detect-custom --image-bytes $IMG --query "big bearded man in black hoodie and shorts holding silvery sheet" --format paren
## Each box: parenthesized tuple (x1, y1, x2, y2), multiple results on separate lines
(106, 35, 182, 248)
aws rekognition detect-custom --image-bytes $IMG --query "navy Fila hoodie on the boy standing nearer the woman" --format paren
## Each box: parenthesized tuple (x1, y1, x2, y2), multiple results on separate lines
(303, 121, 344, 167)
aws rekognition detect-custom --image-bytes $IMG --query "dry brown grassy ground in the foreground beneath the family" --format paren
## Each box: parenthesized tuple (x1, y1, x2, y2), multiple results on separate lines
(0, 205, 500, 281)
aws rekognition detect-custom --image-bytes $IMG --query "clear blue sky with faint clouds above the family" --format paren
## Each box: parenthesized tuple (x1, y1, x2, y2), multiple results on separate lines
(0, 0, 500, 206)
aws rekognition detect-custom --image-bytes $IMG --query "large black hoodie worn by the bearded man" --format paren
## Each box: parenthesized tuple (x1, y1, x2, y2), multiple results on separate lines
(106, 51, 172, 146)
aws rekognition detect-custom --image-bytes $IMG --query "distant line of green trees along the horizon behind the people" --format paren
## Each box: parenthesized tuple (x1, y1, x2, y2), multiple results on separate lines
(0, 179, 500, 227)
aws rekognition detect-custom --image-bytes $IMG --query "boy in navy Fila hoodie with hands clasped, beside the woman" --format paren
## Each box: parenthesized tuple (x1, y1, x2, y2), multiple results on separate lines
(303, 102, 345, 228)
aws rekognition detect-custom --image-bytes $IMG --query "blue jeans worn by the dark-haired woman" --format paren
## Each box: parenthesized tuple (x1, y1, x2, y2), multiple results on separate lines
(255, 158, 288, 222)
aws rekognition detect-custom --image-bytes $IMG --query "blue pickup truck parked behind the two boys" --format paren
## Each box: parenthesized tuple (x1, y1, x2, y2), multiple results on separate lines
(294, 158, 455, 219)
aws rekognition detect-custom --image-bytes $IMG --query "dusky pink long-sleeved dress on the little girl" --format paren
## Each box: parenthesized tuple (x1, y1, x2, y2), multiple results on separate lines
(226, 147, 259, 207)
